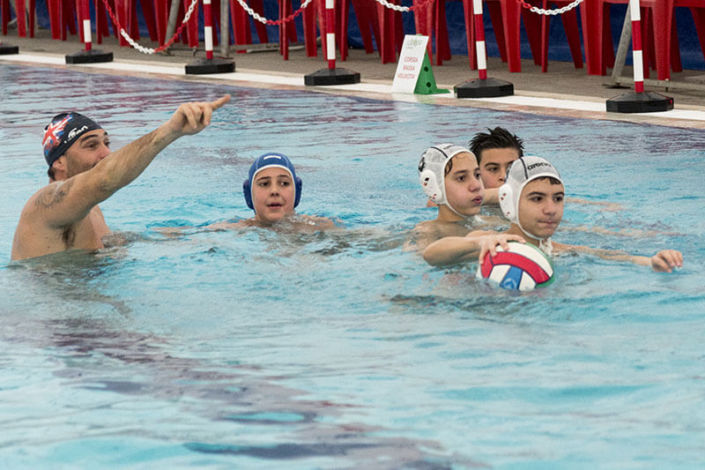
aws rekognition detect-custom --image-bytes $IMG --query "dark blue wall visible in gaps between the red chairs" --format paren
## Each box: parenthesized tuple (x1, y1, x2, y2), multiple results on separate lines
(28, 0, 705, 70)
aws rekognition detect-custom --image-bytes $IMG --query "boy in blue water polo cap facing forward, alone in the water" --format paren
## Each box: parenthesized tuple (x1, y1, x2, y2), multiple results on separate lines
(208, 152, 335, 230)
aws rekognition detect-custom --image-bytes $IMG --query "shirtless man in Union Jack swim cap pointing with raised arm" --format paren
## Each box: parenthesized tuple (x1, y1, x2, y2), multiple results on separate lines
(11, 95, 230, 260)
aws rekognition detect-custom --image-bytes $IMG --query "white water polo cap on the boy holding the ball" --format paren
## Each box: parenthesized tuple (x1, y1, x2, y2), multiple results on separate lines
(498, 156, 563, 236)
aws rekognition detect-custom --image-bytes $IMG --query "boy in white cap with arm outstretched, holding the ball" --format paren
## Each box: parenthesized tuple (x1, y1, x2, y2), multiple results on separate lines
(424, 156, 683, 272)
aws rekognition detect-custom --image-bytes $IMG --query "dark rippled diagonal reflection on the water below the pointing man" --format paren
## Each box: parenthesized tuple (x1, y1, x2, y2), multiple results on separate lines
(0, 252, 472, 469)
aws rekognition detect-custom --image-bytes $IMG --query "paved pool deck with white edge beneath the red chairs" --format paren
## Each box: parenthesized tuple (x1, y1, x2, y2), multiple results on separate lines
(0, 30, 705, 129)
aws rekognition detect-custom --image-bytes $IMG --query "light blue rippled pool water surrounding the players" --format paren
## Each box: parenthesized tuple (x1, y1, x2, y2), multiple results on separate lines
(0, 65, 705, 469)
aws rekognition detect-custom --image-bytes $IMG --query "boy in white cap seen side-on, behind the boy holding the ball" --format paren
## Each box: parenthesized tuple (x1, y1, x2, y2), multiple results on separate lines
(407, 143, 520, 256)
